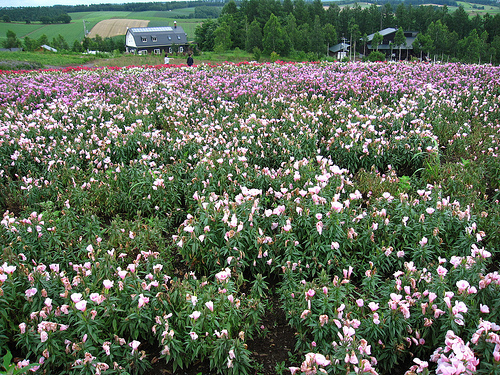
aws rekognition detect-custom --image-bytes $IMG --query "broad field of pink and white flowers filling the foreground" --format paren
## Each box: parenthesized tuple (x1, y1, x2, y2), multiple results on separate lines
(0, 63, 500, 374)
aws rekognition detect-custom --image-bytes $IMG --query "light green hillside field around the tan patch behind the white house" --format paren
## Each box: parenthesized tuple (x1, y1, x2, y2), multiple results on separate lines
(0, 8, 202, 45)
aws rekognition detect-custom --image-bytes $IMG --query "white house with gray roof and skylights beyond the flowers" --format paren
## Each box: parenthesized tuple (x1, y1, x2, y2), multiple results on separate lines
(125, 24, 188, 54)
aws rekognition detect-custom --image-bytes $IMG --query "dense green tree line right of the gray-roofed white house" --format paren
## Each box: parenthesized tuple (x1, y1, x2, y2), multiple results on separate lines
(195, 0, 500, 63)
